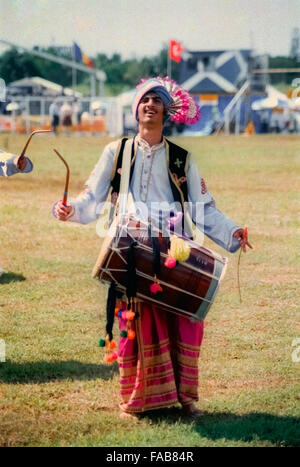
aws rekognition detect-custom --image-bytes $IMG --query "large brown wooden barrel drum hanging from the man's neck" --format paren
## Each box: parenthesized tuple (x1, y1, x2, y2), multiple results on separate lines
(93, 216, 227, 321)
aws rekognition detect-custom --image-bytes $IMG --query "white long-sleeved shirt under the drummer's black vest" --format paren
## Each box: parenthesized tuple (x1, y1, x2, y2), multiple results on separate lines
(69, 137, 240, 251)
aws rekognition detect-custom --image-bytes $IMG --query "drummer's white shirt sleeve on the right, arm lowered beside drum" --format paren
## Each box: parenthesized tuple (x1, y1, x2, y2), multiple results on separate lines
(187, 159, 240, 253)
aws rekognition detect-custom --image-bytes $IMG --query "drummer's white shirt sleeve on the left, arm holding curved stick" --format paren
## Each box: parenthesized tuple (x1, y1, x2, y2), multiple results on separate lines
(68, 142, 117, 224)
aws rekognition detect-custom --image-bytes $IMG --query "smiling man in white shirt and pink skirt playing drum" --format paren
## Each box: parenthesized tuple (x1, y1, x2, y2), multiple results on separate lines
(54, 79, 251, 416)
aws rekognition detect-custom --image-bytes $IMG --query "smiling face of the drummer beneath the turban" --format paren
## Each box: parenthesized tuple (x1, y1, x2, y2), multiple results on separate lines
(138, 92, 164, 127)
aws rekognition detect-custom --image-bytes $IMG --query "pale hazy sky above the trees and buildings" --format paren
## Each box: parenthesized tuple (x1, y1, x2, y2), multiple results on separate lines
(0, 0, 300, 59)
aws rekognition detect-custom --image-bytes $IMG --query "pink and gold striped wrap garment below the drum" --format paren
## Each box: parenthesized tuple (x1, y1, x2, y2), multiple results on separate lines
(118, 302, 203, 413)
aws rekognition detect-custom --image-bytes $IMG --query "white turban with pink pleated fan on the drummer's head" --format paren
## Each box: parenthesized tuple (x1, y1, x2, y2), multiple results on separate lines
(132, 76, 200, 125)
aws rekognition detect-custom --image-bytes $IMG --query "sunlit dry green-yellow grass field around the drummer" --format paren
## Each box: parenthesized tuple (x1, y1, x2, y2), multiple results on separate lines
(0, 135, 300, 447)
